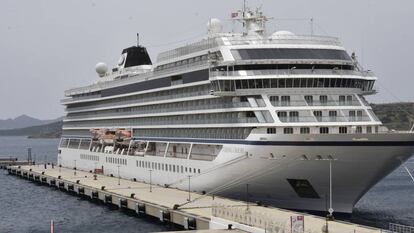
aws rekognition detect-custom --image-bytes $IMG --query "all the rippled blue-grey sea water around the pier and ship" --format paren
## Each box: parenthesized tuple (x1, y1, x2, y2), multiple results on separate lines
(0, 137, 414, 233)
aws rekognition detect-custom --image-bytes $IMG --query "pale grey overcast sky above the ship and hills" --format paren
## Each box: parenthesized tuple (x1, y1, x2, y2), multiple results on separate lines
(0, 0, 414, 119)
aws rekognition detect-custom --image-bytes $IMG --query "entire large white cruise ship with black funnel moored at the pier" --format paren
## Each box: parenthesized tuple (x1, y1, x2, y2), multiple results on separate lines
(58, 8, 414, 214)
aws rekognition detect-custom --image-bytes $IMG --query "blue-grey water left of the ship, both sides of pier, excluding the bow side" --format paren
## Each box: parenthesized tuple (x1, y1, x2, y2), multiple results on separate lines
(0, 137, 176, 233)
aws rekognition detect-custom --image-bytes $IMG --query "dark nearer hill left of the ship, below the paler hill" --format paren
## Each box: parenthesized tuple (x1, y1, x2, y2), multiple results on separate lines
(0, 121, 62, 138)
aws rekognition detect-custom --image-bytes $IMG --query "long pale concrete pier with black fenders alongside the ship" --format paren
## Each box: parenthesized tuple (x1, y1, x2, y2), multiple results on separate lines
(8, 165, 381, 233)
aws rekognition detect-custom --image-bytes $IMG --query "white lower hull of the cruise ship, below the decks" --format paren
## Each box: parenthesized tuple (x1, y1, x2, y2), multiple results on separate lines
(60, 134, 414, 213)
